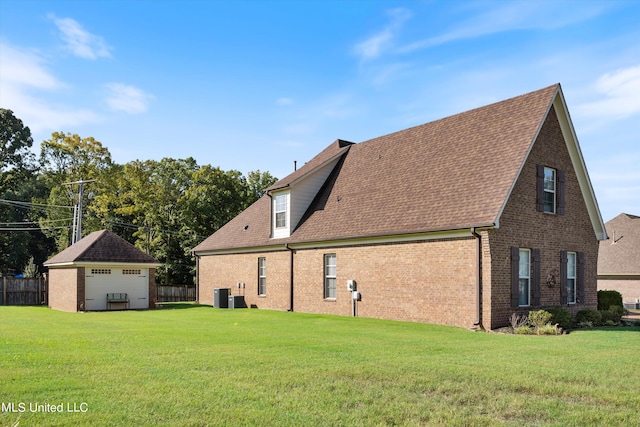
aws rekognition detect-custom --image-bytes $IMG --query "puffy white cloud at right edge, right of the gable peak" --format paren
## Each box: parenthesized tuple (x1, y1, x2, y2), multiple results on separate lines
(576, 65, 640, 119)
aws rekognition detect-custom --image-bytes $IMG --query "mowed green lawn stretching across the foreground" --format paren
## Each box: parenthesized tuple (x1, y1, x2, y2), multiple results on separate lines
(0, 305, 640, 426)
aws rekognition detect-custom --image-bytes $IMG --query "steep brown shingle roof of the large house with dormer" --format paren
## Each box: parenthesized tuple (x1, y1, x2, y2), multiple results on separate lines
(193, 84, 606, 253)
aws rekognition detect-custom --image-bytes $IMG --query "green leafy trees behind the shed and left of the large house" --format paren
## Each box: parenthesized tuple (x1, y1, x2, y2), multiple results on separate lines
(0, 109, 277, 285)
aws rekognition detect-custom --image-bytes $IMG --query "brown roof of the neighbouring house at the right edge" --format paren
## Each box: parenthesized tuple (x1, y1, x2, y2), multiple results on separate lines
(598, 213, 640, 276)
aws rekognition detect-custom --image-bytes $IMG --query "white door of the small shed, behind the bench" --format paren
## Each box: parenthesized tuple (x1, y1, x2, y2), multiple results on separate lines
(85, 267, 149, 311)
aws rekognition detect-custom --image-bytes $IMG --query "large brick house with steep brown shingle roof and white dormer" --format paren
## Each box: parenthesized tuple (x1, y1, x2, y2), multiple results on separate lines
(193, 85, 606, 328)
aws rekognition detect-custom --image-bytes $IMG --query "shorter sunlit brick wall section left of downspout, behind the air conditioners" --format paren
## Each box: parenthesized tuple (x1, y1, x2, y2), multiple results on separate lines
(198, 250, 291, 310)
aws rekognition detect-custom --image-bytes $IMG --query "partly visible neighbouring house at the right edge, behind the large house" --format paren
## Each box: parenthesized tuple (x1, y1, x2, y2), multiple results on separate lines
(598, 213, 640, 308)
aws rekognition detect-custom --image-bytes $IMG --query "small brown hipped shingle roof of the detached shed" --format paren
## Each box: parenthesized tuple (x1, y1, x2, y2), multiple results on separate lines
(44, 230, 159, 266)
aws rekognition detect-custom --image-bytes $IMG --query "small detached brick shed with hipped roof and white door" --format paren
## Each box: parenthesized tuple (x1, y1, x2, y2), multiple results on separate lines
(44, 230, 160, 311)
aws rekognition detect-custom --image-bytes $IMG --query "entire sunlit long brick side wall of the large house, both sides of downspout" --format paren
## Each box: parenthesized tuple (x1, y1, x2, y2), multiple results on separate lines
(199, 238, 476, 327)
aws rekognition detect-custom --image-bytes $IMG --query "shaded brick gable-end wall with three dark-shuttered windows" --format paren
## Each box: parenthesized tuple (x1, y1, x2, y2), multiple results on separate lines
(484, 109, 598, 328)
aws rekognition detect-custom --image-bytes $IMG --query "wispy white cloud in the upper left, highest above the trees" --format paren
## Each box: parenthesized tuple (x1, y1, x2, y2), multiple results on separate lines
(49, 15, 111, 59)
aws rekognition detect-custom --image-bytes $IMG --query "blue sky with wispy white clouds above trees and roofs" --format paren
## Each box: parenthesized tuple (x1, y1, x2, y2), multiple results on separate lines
(0, 0, 640, 221)
